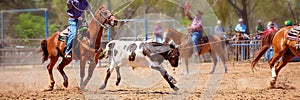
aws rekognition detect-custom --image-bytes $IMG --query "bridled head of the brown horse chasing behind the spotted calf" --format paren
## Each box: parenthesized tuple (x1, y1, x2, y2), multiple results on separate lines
(96, 6, 118, 26)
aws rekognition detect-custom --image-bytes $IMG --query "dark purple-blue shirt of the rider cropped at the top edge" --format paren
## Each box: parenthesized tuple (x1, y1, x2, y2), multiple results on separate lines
(67, 0, 89, 18)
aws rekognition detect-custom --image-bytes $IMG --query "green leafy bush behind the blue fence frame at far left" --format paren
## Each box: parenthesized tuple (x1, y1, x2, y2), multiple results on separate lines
(13, 13, 58, 39)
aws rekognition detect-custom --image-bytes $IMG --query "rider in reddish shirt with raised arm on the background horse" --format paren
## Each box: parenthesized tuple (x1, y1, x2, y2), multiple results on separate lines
(185, 10, 203, 55)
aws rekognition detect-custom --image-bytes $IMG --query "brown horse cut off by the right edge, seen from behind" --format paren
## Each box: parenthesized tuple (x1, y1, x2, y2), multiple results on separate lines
(251, 26, 300, 87)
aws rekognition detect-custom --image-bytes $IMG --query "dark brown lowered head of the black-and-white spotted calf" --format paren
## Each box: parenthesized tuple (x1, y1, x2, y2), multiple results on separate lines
(167, 44, 180, 67)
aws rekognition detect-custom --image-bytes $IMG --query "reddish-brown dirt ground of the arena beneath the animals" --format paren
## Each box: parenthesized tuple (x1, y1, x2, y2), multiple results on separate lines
(0, 62, 300, 100)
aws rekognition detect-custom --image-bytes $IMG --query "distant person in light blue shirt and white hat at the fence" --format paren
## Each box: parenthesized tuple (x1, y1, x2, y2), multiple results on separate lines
(232, 19, 250, 40)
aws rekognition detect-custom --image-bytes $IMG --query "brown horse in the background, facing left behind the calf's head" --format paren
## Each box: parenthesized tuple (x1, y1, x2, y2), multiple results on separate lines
(164, 28, 227, 74)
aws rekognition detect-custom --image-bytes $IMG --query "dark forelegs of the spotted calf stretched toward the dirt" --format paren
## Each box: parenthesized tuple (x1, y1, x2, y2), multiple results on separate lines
(151, 65, 179, 91)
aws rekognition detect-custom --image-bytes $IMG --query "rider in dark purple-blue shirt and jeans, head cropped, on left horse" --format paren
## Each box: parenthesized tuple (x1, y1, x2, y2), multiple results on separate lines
(65, 0, 90, 58)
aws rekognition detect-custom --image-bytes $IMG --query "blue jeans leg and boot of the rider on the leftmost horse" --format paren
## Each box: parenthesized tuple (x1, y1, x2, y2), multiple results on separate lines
(65, 18, 78, 54)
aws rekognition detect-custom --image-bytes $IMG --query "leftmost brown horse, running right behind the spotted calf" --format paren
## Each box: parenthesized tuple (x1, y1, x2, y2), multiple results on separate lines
(41, 6, 116, 91)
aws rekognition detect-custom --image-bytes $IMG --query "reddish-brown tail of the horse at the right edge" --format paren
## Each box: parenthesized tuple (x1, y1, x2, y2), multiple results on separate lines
(251, 32, 276, 70)
